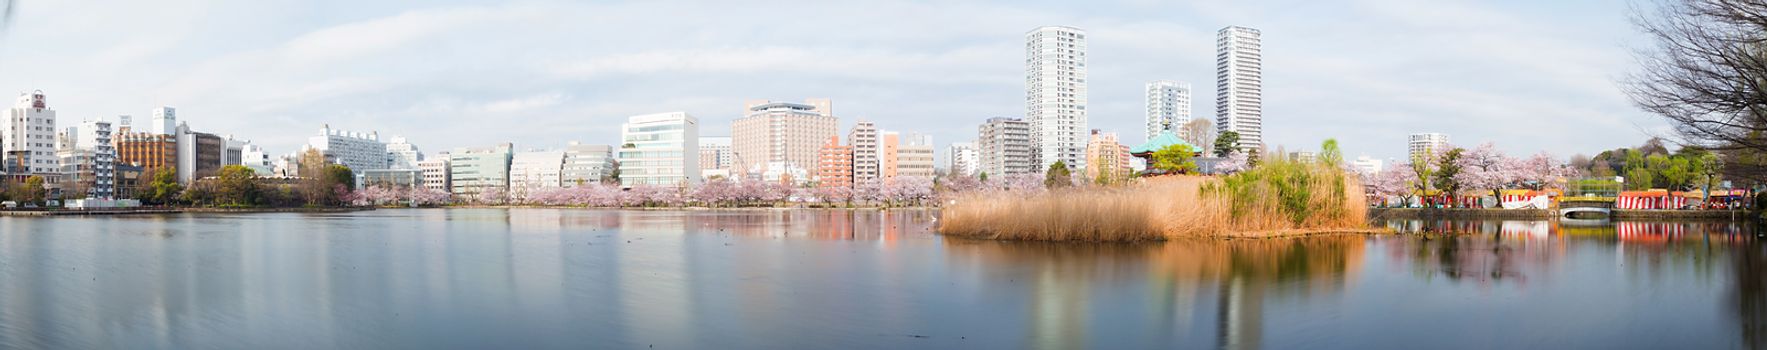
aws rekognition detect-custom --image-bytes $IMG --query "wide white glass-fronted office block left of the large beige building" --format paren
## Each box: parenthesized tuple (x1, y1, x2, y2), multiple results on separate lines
(618, 111, 700, 187)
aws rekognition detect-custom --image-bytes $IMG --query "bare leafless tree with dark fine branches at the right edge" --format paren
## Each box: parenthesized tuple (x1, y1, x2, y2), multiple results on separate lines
(1626, 0, 1767, 173)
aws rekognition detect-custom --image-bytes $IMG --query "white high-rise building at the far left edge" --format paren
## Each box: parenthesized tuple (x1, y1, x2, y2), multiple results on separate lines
(0, 90, 62, 177)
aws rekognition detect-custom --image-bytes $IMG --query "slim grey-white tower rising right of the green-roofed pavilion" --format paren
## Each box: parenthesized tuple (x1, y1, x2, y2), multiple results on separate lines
(1216, 27, 1263, 152)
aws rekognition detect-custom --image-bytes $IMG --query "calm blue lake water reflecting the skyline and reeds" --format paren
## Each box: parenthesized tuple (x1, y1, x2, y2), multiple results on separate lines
(0, 209, 1767, 348)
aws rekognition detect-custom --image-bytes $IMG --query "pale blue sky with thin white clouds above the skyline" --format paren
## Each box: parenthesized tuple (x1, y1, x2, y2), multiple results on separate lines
(0, 0, 1668, 164)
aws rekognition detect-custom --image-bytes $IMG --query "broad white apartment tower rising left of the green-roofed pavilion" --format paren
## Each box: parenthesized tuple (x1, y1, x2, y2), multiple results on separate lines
(1025, 27, 1088, 170)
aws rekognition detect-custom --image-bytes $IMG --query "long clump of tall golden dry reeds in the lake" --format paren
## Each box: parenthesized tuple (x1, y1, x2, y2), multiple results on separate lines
(938, 161, 1368, 242)
